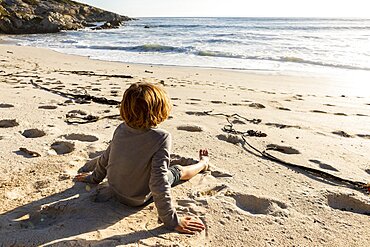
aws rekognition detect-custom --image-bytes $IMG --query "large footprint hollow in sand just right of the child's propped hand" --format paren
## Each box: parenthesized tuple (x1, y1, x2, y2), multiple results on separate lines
(226, 192, 288, 217)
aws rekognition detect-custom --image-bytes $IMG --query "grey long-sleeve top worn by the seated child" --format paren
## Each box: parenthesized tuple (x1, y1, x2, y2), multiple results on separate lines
(90, 123, 179, 229)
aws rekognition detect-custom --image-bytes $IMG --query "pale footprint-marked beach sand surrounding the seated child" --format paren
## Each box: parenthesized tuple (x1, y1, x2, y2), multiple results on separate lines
(0, 45, 370, 247)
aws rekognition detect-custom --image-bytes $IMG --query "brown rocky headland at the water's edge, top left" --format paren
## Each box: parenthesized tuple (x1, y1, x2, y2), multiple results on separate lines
(0, 0, 131, 34)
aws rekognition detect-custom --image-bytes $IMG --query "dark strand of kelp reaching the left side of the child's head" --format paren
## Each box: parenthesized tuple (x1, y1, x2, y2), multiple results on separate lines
(30, 80, 121, 105)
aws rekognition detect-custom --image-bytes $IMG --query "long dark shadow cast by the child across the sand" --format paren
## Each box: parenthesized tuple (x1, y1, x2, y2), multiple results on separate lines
(0, 183, 168, 246)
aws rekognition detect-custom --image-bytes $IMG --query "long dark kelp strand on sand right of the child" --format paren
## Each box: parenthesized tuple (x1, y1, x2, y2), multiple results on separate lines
(204, 111, 370, 192)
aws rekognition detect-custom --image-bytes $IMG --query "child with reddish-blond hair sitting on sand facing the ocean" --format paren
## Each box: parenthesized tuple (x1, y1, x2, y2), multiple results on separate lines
(75, 83, 209, 234)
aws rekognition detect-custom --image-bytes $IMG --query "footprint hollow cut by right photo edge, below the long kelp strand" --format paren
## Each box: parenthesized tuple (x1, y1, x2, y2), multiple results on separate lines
(327, 193, 370, 216)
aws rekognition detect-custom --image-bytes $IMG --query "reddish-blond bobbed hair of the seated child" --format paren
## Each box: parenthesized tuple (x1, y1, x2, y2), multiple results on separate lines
(120, 83, 171, 129)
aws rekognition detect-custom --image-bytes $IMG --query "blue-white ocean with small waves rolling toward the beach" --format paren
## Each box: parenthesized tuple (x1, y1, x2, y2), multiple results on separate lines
(7, 18, 370, 73)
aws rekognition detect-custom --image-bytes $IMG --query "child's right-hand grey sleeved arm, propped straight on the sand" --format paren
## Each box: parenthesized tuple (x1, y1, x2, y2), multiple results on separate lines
(149, 135, 180, 230)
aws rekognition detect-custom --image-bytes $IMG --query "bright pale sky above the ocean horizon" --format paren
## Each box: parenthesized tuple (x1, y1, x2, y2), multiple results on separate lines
(75, 0, 370, 18)
